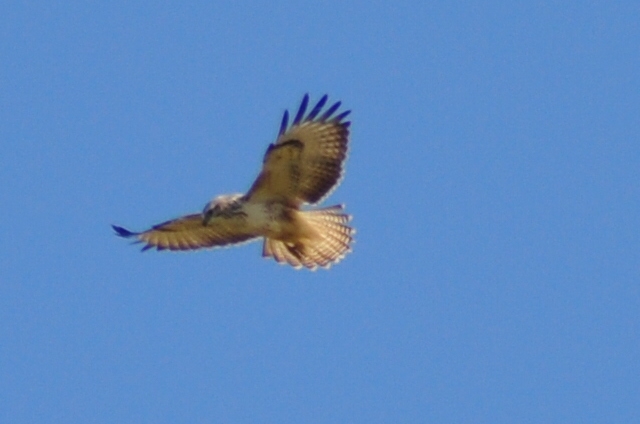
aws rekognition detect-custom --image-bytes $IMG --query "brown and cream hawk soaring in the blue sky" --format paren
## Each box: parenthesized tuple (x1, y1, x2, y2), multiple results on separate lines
(112, 94, 355, 270)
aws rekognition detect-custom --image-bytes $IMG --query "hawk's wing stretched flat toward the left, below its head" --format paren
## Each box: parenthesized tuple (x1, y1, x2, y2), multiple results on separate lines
(112, 214, 259, 251)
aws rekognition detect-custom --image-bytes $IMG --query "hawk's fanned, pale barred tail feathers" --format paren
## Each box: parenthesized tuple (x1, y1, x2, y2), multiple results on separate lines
(262, 205, 356, 270)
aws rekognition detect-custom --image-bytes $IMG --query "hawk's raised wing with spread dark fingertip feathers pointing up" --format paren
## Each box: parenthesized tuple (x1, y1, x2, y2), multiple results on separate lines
(247, 94, 351, 205)
